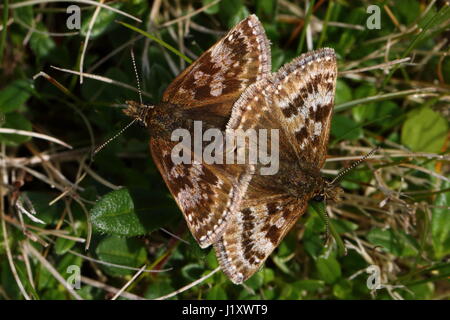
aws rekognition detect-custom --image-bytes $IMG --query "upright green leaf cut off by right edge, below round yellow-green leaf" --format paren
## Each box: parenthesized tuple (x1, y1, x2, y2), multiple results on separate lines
(431, 182, 450, 260)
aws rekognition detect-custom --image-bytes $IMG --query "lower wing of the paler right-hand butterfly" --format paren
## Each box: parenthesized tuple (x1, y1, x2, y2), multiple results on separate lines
(214, 189, 308, 284)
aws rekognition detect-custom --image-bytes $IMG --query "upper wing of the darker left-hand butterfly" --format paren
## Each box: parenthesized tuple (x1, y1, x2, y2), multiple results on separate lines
(163, 15, 271, 118)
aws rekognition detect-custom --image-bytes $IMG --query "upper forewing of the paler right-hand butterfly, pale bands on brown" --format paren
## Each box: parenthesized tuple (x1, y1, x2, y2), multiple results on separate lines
(273, 48, 337, 168)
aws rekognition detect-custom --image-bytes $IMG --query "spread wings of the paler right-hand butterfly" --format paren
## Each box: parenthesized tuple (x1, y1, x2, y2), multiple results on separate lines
(214, 49, 337, 283)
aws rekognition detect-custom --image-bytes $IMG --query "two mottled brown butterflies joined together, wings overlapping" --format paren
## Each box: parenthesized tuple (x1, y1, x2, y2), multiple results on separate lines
(125, 15, 337, 283)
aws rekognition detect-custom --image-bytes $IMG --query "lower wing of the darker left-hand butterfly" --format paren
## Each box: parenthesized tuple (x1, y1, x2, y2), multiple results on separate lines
(150, 138, 250, 248)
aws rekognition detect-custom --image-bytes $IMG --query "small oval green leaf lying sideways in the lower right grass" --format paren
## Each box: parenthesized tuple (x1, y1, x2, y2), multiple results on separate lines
(367, 228, 418, 257)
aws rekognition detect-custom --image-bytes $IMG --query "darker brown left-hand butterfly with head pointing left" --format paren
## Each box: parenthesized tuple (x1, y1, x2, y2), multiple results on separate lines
(125, 15, 271, 248)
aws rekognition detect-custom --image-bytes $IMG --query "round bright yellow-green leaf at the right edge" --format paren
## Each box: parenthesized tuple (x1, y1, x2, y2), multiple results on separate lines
(401, 107, 448, 153)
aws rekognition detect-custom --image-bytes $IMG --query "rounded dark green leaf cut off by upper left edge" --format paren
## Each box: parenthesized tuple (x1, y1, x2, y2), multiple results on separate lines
(0, 80, 32, 113)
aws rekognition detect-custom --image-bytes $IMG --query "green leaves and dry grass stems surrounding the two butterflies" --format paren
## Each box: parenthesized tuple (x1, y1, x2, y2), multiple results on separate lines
(0, 0, 450, 299)
